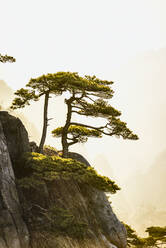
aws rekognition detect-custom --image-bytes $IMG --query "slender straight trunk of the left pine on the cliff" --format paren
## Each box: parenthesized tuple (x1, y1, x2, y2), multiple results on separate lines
(39, 92, 49, 153)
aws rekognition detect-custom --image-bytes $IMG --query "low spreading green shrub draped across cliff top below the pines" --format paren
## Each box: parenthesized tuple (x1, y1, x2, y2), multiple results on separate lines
(18, 153, 120, 194)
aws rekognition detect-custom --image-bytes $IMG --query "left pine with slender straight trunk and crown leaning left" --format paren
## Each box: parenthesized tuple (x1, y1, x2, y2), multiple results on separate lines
(11, 74, 63, 153)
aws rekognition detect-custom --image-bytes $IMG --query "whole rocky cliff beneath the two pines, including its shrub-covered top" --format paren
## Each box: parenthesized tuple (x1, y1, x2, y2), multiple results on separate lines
(0, 111, 126, 248)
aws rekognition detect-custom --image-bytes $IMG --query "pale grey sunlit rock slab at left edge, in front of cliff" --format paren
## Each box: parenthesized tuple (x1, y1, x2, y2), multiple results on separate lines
(0, 116, 29, 248)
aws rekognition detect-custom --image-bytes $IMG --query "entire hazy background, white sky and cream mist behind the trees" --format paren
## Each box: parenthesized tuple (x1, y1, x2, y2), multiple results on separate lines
(0, 0, 166, 236)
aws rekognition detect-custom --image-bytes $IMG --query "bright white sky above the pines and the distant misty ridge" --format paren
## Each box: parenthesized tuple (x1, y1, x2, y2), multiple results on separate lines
(0, 0, 166, 89)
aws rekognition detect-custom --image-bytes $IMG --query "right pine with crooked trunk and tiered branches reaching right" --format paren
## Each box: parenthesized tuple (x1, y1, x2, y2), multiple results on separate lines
(52, 72, 138, 157)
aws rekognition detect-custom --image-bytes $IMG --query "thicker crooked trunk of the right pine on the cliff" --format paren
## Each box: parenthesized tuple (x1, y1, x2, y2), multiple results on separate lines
(62, 98, 73, 158)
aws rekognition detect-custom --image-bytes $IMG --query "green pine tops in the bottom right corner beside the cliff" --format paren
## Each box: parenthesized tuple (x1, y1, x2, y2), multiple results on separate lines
(125, 224, 166, 248)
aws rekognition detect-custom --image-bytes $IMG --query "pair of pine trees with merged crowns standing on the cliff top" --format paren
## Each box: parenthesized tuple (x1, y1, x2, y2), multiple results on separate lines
(11, 72, 138, 158)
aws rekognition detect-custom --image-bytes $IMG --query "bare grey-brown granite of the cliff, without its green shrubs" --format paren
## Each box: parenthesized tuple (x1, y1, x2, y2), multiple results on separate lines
(0, 111, 126, 248)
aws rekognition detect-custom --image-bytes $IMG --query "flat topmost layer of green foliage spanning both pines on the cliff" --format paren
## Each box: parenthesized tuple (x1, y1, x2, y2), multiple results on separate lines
(12, 72, 112, 105)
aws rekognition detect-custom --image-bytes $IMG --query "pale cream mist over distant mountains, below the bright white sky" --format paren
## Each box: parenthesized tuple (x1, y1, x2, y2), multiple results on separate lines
(0, 48, 166, 234)
